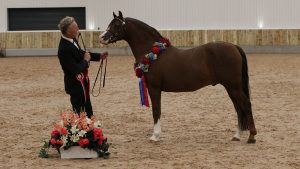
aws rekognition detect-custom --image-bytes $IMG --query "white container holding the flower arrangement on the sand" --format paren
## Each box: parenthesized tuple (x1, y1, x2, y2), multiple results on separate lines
(60, 146, 98, 159)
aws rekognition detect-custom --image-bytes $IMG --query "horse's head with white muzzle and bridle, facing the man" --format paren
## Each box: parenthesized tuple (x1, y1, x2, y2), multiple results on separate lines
(99, 11, 125, 45)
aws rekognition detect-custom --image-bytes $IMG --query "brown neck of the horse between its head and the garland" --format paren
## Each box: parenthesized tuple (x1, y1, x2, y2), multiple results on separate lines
(125, 19, 158, 62)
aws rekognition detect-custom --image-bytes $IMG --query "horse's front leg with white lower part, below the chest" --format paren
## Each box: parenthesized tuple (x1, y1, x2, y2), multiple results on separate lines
(148, 87, 161, 141)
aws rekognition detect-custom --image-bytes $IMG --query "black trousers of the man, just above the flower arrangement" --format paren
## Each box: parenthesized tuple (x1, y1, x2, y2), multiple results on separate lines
(70, 92, 93, 118)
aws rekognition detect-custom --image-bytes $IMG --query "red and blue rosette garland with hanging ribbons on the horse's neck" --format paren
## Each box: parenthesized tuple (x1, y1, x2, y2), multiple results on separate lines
(135, 38, 171, 107)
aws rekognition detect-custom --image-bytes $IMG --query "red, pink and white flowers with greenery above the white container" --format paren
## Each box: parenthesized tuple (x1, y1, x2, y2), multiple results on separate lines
(39, 112, 110, 158)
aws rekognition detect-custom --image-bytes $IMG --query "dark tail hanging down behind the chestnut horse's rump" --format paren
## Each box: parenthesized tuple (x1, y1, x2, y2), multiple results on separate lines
(236, 46, 250, 100)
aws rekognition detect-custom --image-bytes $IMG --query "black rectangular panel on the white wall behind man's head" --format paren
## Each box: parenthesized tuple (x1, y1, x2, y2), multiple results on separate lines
(7, 7, 86, 31)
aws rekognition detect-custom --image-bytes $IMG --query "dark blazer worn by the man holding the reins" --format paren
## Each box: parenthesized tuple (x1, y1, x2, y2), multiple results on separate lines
(57, 38, 101, 94)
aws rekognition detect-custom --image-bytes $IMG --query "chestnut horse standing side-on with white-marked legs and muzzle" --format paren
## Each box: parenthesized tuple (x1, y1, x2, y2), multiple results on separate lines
(99, 11, 257, 143)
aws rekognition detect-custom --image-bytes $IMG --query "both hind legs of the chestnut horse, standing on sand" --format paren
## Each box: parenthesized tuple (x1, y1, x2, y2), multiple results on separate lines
(225, 87, 257, 143)
